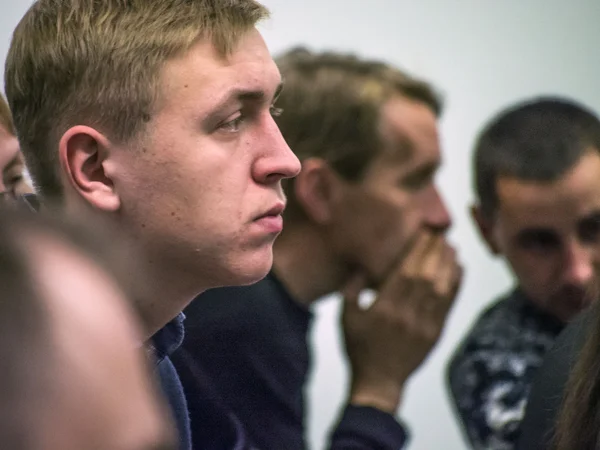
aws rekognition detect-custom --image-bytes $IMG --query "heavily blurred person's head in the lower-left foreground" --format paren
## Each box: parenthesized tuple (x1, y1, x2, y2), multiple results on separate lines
(0, 208, 177, 450)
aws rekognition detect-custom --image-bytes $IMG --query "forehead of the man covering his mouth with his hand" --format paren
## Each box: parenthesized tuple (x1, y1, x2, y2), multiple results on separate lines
(380, 95, 441, 170)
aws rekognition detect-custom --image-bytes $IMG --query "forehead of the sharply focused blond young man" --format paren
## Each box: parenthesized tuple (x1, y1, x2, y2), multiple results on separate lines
(161, 29, 281, 109)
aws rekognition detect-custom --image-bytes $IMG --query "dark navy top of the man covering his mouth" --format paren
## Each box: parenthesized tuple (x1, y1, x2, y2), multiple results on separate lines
(174, 275, 406, 450)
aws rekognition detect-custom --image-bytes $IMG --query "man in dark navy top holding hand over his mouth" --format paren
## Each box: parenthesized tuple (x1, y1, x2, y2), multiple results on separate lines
(176, 49, 462, 450)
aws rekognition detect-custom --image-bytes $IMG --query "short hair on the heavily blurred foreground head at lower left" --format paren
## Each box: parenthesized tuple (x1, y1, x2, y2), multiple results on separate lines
(0, 208, 148, 449)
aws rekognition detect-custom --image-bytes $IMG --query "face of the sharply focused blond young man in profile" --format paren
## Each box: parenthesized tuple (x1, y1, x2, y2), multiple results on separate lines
(109, 30, 300, 289)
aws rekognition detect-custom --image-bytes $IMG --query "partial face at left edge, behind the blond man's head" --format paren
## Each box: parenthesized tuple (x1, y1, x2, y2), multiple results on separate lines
(0, 126, 32, 199)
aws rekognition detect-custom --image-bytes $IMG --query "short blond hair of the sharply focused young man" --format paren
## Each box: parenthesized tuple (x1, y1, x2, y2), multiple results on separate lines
(5, 0, 268, 200)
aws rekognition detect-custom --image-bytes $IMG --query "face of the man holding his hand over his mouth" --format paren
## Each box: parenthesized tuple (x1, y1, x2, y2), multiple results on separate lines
(328, 97, 451, 286)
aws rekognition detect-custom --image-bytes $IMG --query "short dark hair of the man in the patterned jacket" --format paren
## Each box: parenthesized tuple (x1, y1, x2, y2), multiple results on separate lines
(474, 97, 600, 218)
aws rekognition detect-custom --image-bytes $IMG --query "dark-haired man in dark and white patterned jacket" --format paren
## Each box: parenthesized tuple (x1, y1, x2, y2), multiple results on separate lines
(447, 98, 600, 450)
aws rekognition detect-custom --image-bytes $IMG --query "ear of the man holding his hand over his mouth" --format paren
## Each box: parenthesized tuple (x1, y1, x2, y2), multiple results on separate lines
(294, 158, 339, 225)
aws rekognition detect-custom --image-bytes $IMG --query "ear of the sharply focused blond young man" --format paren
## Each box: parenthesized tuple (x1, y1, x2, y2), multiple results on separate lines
(58, 125, 121, 211)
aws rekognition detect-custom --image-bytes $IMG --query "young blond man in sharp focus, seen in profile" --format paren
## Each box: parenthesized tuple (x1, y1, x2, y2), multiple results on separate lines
(5, 0, 300, 450)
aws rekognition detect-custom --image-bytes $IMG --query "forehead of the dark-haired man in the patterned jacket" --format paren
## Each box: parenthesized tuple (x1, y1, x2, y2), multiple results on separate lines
(497, 151, 600, 226)
